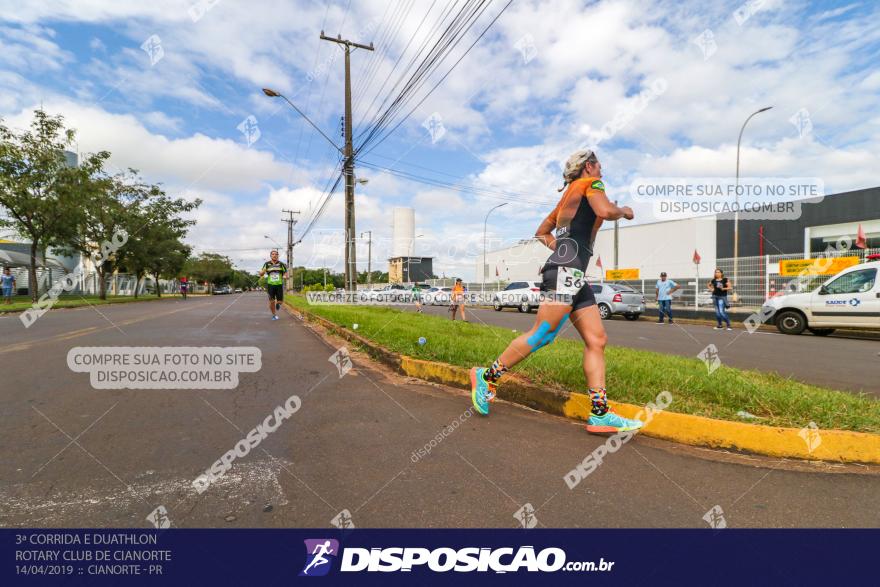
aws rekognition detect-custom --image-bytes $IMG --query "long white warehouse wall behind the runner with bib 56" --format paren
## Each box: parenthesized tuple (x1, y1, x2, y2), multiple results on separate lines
(475, 216, 716, 281)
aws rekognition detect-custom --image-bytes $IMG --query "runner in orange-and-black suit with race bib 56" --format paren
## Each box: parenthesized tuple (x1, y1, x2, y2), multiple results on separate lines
(470, 150, 642, 433)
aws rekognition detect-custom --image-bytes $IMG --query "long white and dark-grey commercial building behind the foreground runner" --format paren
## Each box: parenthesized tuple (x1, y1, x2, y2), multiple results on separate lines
(475, 187, 880, 304)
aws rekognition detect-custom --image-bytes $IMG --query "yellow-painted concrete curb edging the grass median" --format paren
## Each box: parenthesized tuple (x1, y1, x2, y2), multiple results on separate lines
(287, 305, 880, 464)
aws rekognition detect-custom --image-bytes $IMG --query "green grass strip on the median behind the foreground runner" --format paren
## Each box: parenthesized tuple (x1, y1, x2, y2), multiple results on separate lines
(285, 295, 880, 432)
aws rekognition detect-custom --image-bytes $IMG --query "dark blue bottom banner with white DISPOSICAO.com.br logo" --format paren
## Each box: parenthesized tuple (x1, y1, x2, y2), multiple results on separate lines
(2, 529, 880, 586)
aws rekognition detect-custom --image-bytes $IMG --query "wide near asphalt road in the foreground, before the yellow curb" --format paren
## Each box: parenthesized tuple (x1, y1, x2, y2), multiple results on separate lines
(0, 293, 880, 528)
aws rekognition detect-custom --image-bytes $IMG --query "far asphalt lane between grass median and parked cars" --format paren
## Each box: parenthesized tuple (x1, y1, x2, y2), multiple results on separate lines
(416, 306, 880, 398)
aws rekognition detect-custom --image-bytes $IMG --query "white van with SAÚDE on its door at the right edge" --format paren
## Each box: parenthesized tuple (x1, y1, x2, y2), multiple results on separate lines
(761, 261, 880, 336)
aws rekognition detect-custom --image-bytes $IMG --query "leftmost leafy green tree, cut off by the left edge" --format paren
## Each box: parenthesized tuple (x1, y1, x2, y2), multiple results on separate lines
(0, 109, 109, 302)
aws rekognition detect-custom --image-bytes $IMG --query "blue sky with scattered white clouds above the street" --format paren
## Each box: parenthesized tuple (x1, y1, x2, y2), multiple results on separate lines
(0, 0, 880, 278)
